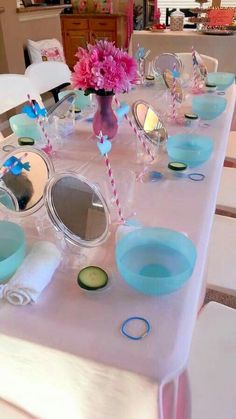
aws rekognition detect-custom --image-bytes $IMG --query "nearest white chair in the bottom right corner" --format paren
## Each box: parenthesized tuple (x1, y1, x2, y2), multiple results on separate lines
(188, 302, 236, 419)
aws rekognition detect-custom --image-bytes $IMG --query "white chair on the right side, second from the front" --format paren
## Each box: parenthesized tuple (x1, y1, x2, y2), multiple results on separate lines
(206, 215, 236, 297)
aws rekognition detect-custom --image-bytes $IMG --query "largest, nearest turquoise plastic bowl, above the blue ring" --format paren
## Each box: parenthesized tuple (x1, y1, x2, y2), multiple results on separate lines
(115, 227, 196, 295)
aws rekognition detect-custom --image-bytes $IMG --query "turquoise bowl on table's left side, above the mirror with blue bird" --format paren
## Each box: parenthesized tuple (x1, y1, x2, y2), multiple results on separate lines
(9, 113, 41, 141)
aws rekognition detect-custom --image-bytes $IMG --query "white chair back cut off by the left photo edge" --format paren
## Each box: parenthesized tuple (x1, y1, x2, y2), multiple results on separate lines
(0, 74, 42, 114)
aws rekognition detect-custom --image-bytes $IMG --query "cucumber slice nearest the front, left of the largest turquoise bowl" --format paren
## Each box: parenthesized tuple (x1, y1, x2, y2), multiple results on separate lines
(77, 266, 108, 291)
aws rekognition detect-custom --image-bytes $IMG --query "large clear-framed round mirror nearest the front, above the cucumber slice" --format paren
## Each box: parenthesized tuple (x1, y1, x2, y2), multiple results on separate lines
(45, 172, 109, 247)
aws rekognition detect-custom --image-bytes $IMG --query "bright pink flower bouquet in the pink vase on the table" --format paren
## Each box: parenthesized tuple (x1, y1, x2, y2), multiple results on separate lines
(72, 40, 137, 96)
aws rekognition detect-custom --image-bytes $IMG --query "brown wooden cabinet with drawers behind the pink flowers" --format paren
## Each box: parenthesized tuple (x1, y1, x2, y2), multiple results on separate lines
(61, 14, 127, 68)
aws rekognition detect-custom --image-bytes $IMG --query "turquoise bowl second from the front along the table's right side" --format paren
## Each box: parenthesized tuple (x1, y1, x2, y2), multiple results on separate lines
(166, 134, 213, 167)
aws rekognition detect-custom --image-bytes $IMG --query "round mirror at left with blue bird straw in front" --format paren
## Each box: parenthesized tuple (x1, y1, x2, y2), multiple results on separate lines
(0, 147, 54, 215)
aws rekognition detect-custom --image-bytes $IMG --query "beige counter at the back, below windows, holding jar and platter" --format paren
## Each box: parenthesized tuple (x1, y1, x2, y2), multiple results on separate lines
(129, 29, 236, 73)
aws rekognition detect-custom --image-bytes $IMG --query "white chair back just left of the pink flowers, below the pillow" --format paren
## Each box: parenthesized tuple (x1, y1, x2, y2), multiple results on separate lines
(25, 61, 71, 102)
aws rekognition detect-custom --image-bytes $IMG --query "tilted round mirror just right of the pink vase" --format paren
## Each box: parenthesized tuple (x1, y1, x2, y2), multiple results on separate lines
(132, 100, 168, 146)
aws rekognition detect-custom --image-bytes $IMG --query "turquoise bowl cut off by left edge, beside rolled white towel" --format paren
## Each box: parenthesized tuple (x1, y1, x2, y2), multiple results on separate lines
(0, 221, 25, 283)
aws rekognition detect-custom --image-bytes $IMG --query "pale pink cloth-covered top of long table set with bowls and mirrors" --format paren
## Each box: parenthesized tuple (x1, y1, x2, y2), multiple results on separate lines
(0, 86, 236, 418)
